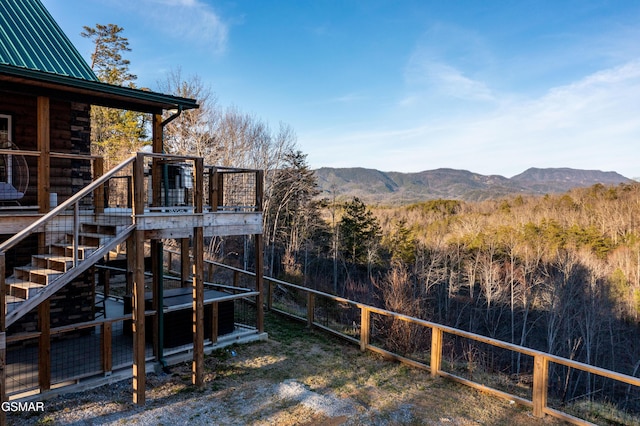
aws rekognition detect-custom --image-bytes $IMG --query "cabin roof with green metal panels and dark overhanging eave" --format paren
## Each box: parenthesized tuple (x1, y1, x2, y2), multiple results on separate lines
(0, 0, 198, 113)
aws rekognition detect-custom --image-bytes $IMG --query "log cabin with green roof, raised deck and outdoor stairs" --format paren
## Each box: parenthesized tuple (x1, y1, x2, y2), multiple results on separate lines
(0, 0, 264, 404)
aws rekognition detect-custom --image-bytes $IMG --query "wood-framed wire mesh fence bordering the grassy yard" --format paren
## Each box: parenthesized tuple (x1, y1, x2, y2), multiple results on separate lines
(211, 262, 640, 424)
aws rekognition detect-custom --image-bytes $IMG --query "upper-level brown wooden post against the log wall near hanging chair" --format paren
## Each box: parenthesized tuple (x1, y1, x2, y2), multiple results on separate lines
(36, 96, 51, 213)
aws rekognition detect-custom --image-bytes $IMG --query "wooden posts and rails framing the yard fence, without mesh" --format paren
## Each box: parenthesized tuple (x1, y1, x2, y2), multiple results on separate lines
(207, 262, 640, 425)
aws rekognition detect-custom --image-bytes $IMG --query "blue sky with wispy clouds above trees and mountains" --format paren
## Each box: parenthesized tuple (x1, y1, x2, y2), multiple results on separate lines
(42, 0, 640, 177)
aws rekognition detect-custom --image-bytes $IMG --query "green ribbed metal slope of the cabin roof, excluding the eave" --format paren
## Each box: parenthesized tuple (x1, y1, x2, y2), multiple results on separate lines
(0, 0, 98, 81)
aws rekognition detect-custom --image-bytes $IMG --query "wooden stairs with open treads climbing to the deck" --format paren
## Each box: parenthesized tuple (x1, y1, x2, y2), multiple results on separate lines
(5, 215, 134, 322)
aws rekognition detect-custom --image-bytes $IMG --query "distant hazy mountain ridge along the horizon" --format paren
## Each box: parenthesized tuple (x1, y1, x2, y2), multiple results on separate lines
(314, 167, 633, 204)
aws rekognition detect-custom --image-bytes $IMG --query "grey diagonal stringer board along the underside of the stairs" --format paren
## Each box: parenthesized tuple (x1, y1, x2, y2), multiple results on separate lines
(5, 223, 136, 327)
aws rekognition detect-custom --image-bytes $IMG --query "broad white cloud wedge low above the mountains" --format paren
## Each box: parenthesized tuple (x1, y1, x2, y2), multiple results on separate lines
(304, 61, 640, 177)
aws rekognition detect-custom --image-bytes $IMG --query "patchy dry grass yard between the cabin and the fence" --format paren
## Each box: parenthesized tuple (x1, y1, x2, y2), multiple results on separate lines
(9, 315, 560, 425)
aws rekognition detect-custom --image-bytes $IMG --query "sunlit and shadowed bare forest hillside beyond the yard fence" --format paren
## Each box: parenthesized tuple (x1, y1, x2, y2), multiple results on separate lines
(256, 166, 640, 410)
